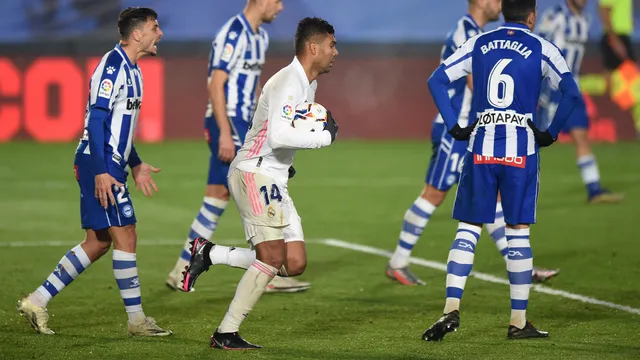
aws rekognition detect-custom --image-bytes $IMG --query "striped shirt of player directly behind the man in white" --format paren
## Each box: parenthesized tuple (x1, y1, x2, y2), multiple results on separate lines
(206, 13, 269, 129)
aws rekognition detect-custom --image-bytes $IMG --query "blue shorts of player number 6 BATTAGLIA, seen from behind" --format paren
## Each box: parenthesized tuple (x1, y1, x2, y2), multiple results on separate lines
(453, 152, 540, 225)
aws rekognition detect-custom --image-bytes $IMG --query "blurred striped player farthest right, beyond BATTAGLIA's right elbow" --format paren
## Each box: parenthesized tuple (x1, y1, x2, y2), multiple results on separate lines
(538, 0, 622, 203)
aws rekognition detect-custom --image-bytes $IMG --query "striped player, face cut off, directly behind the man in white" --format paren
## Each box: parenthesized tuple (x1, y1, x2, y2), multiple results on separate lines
(167, 0, 311, 292)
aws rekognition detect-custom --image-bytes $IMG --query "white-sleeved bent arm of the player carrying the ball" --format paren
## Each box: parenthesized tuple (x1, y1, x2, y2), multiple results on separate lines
(267, 89, 337, 150)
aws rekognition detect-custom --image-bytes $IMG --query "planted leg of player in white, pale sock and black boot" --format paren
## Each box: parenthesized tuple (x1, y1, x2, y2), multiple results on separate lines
(211, 240, 286, 350)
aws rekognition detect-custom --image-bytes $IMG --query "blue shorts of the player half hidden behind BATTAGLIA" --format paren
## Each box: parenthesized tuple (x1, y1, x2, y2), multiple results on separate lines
(425, 132, 469, 192)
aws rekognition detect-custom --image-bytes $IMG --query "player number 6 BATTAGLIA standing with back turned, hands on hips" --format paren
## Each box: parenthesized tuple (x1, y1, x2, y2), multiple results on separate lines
(422, 0, 582, 341)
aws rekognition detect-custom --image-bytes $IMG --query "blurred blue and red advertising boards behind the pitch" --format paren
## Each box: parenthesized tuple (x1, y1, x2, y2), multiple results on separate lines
(0, 0, 640, 142)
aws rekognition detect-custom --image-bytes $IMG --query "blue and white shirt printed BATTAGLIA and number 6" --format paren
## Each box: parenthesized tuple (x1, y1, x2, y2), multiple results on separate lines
(434, 23, 571, 157)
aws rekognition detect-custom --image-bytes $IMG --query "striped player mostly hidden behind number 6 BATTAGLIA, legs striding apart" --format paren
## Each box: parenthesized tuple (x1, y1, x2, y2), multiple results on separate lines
(386, 0, 558, 285)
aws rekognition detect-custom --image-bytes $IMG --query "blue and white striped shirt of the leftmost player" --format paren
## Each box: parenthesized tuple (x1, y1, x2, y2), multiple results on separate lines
(77, 44, 143, 168)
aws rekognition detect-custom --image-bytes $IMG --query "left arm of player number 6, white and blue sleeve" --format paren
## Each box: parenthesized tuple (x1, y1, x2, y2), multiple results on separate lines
(428, 38, 476, 137)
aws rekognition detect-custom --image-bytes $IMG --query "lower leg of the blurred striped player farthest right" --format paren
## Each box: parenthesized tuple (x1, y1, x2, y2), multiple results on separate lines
(571, 128, 623, 204)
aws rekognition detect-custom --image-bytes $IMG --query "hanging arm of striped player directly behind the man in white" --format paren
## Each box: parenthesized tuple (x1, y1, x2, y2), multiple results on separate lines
(208, 31, 244, 162)
